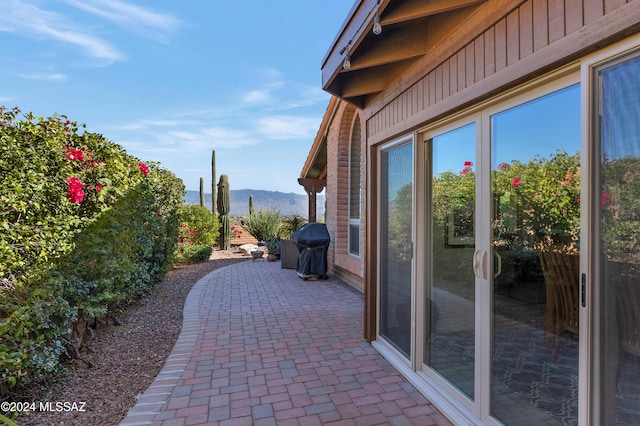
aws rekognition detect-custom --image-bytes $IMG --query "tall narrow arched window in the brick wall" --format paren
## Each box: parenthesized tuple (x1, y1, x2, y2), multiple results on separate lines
(349, 115, 362, 256)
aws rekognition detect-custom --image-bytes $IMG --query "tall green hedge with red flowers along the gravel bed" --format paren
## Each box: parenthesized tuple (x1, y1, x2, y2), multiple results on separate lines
(0, 108, 184, 400)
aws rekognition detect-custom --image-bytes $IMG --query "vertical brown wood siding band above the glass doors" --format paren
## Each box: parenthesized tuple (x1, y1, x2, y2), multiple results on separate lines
(365, 0, 640, 145)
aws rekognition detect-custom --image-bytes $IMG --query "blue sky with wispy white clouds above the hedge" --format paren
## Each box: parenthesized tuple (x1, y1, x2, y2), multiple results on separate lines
(0, 0, 353, 193)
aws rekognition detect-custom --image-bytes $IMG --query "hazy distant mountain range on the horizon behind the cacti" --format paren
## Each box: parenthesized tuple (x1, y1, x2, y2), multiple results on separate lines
(183, 189, 324, 218)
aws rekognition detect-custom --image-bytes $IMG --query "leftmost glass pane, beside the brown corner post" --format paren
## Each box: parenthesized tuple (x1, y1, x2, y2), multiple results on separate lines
(379, 141, 413, 358)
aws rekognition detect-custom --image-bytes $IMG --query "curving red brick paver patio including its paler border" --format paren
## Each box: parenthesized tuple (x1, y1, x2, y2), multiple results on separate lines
(120, 261, 450, 426)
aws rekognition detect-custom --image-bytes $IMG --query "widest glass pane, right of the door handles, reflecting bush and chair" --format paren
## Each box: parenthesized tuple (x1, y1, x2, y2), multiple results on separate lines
(489, 85, 580, 425)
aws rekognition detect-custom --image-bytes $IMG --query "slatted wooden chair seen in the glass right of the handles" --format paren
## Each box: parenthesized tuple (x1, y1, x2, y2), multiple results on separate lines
(540, 250, 580, 363)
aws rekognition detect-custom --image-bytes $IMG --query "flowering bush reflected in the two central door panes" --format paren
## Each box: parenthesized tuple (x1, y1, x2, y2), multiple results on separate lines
(433, 151, 580, 249)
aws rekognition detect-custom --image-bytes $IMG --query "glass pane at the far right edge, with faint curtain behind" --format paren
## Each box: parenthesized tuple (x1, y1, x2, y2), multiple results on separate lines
(592, 49, 640, 425)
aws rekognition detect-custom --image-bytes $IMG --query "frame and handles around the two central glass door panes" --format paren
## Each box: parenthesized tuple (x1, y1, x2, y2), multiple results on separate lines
(412, 68, 589, 425)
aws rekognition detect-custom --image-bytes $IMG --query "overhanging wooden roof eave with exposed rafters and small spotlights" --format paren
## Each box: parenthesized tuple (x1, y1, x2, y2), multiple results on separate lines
(322, 0, 486, 108)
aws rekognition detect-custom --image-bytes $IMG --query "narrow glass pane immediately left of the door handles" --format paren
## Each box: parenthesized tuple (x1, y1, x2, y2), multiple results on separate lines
(424, 124, 476, 400)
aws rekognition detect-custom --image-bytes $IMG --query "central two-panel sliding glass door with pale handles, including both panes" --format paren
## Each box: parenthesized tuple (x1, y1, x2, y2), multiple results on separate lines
(416, 79, 581, 425)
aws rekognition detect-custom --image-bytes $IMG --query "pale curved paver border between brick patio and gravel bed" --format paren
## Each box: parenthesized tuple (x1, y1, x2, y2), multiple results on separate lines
(120, 262, 243, 426)
